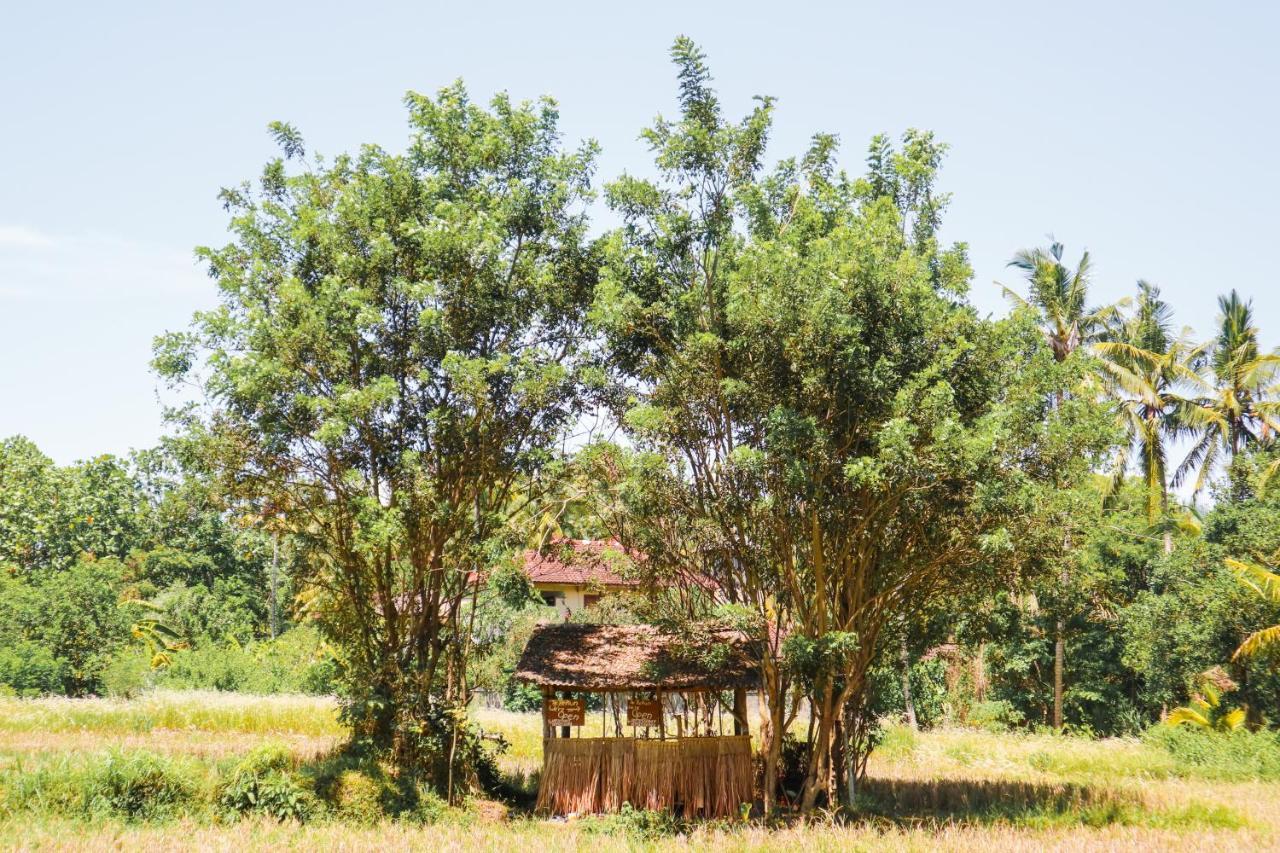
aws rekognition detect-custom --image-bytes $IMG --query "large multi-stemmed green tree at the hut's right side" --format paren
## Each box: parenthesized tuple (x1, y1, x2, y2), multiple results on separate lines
(595, 40, 1108, 808)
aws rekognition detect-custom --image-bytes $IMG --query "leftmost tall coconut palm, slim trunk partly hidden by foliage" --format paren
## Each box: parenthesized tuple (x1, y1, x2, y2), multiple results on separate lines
(1004, 241, 1116, 729)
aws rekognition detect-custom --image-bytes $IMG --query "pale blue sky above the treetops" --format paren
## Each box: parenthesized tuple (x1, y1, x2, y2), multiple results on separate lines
(0, 0, 1280, 464)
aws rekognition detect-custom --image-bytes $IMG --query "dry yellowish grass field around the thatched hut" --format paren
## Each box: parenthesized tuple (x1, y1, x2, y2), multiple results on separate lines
(0, 693, 1280, 853)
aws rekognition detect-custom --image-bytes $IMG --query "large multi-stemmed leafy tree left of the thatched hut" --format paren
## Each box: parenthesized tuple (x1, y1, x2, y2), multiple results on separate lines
(155, 83, 596, 792)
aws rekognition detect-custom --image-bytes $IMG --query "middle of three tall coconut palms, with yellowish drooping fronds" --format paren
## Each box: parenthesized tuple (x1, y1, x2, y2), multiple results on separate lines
(1093, 280, 1208, 553)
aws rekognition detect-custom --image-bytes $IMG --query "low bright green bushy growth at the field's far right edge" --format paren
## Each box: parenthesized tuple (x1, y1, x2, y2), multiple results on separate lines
(1143, 725, 1280, 781)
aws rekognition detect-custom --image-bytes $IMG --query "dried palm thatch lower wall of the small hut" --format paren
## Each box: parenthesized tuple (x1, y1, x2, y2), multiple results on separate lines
(538, 735, 753, 817)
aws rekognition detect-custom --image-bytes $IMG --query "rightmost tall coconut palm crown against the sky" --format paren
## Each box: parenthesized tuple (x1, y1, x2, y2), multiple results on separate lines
(1174, 291, 1280, 493)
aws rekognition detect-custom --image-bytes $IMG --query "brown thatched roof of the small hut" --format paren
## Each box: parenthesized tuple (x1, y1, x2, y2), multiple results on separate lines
(516, 622, 758, 690)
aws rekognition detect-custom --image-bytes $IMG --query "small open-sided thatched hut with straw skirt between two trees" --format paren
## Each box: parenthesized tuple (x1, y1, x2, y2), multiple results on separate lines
(516, 624, 756, 817)
